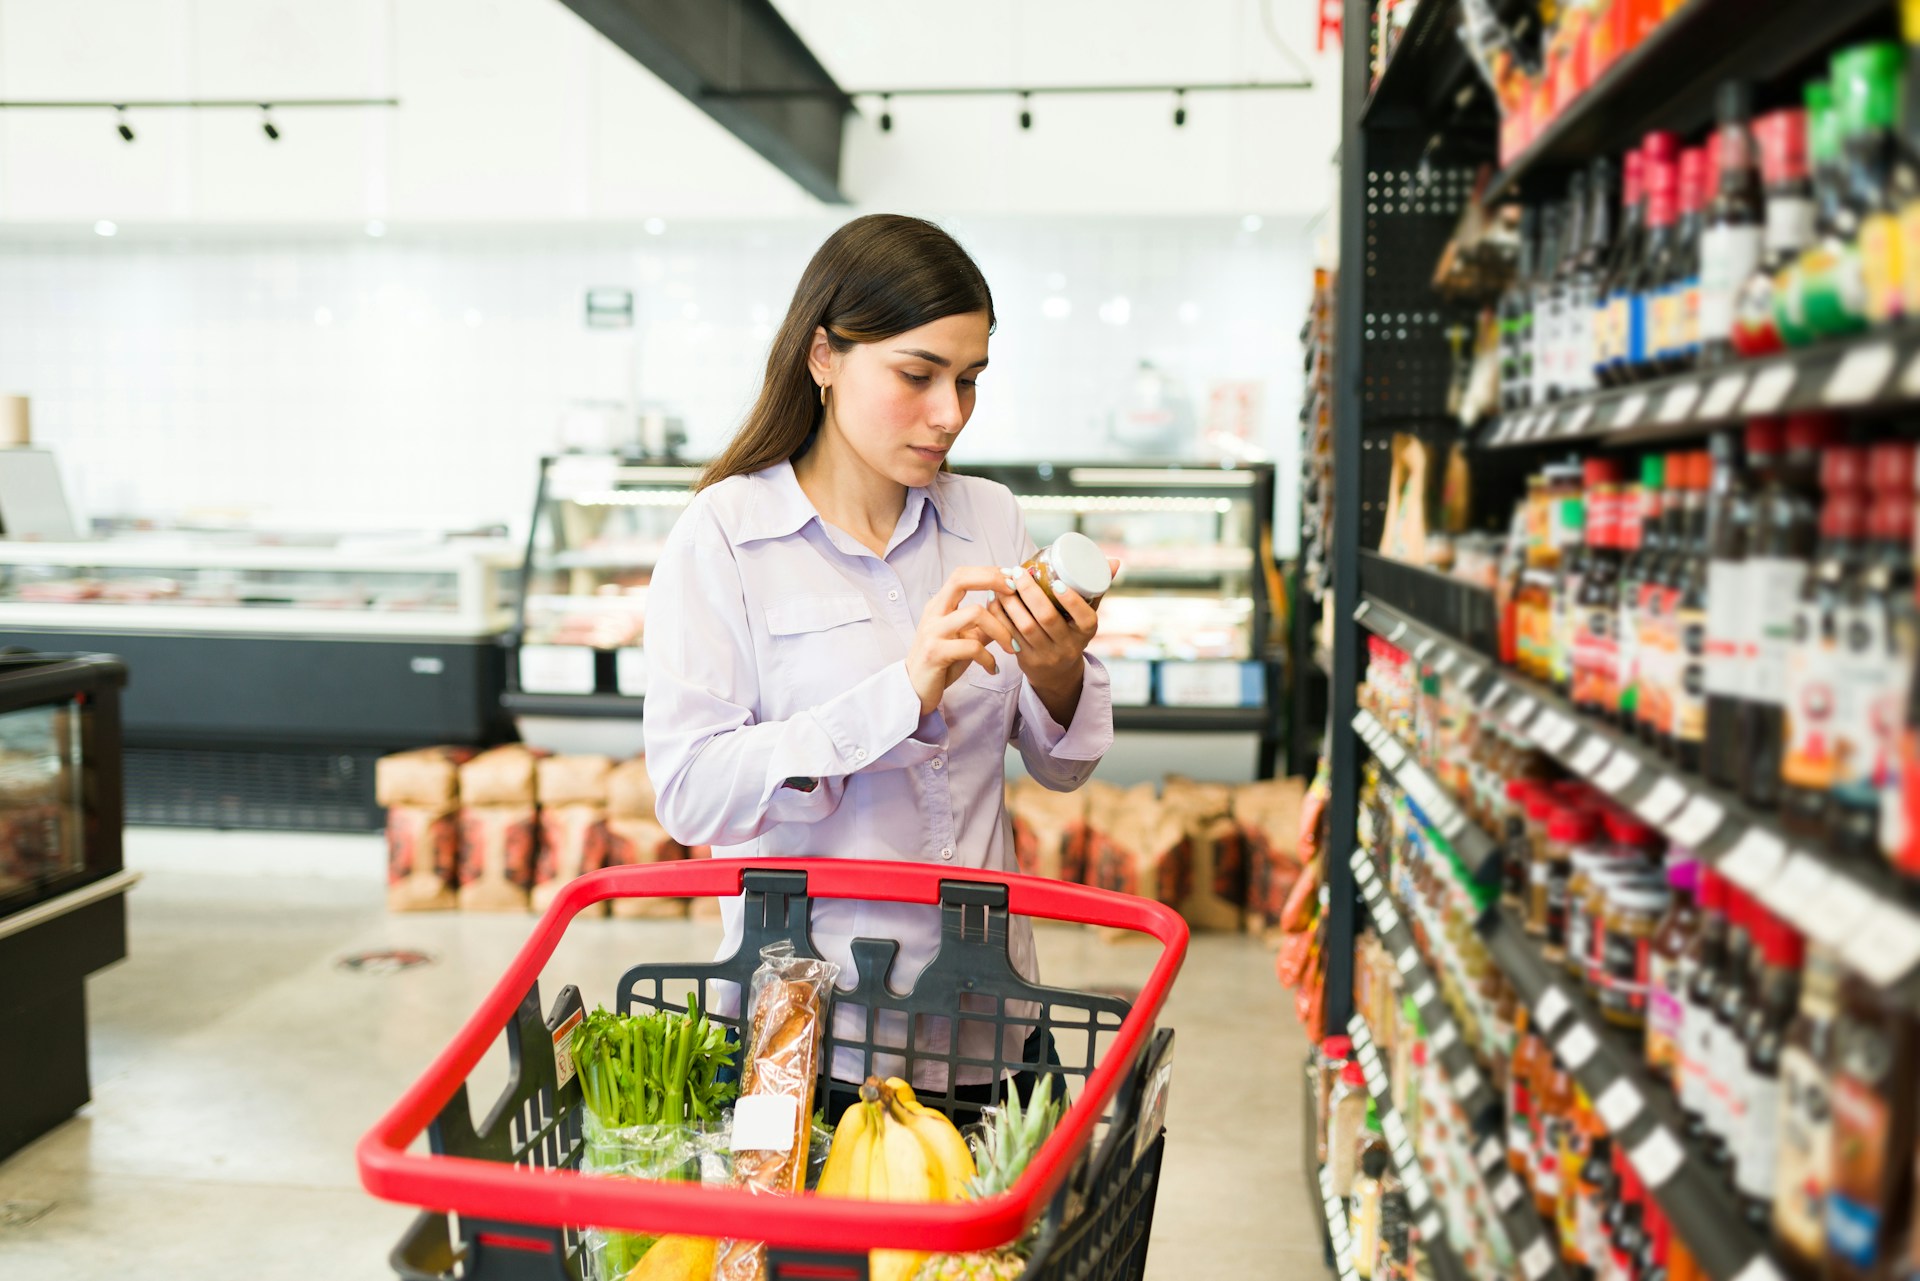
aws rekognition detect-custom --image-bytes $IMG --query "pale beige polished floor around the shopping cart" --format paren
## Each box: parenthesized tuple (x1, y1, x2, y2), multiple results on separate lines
(0, 872, 1325, 1281)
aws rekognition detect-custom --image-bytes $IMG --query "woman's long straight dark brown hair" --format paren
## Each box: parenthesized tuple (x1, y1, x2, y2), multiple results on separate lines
(693, 213, 995, 490)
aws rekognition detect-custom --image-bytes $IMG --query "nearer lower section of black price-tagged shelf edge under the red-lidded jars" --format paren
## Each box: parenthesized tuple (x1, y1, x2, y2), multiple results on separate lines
(1482, 910, 1778, 1281)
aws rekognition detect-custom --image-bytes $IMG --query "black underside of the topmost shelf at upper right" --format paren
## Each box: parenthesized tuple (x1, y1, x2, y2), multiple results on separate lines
(1486, 0, 1893, 200)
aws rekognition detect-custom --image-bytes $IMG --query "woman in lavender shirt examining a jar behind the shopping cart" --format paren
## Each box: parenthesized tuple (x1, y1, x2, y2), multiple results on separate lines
(645, 215, 1114, 1100)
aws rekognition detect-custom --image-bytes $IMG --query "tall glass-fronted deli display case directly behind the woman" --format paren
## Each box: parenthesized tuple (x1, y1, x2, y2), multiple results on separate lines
(503, 455, 1281, 778)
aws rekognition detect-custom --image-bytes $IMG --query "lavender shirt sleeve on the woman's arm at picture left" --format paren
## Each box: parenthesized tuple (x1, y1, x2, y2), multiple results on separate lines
(643, 503, 945, 845)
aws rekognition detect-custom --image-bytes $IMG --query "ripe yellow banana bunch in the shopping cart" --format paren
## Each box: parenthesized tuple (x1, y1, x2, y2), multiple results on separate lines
(816, 1076, 975, 1281)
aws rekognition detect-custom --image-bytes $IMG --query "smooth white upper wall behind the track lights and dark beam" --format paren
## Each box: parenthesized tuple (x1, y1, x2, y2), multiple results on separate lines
(0, 0, 1338, 227)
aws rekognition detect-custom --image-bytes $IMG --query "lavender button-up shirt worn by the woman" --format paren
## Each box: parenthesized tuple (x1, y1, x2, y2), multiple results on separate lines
(645, 463, 1114, 1091)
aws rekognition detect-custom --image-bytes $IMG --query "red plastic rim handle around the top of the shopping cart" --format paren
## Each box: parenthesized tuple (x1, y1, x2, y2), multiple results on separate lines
(357, 858, 1187, 1250)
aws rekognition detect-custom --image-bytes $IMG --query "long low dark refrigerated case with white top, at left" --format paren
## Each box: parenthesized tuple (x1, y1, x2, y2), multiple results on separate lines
(0, 530, 520, 830)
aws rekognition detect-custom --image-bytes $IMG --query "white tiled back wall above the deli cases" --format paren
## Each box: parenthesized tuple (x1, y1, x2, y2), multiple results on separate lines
(0, 213, 1311, 530)
